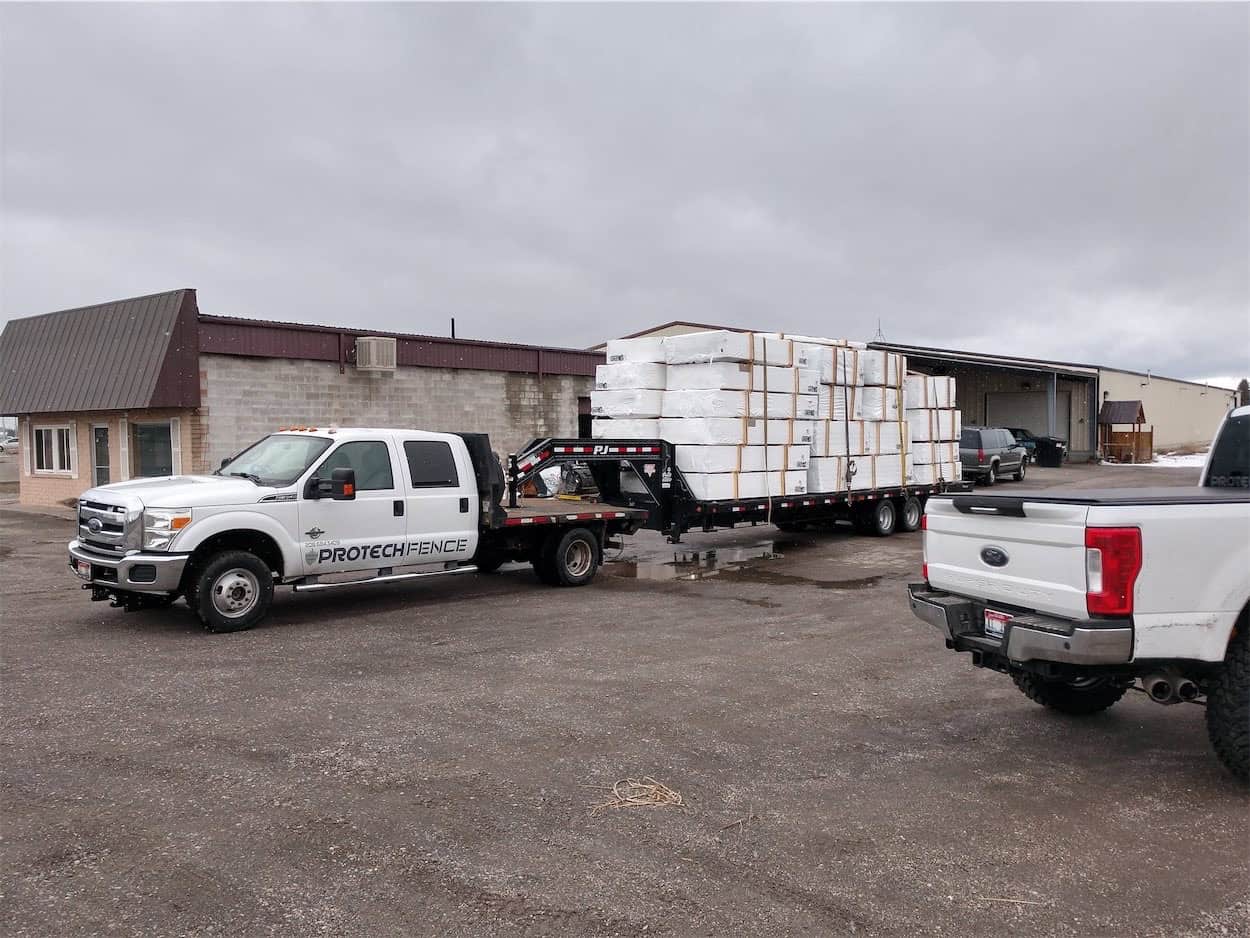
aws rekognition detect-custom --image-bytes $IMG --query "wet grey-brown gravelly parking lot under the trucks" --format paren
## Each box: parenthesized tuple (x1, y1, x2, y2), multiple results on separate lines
(0, 466, 1250, 935)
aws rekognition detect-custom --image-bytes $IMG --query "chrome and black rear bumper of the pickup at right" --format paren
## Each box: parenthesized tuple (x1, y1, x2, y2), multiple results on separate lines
(908, 583, 1133, 665)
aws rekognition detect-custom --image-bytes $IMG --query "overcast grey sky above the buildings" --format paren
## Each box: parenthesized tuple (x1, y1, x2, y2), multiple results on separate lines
(0, 4, 1250, 376)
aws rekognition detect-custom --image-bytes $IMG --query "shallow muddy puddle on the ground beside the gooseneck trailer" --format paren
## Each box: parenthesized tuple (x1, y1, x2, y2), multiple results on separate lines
(603, 542, 881, 589)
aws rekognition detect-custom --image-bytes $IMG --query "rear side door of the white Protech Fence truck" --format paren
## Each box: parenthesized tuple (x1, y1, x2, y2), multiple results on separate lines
(396, 435, 479, 564)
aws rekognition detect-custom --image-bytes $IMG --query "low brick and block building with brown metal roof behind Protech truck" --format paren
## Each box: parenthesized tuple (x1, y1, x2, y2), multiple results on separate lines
(0, 289, 604, 505)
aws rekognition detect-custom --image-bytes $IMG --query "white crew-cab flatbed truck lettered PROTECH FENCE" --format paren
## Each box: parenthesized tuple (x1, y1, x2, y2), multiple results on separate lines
(69, 426, 646, 632)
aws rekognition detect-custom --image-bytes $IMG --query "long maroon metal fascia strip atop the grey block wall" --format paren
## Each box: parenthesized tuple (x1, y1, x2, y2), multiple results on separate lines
(200, 315, 604, 375)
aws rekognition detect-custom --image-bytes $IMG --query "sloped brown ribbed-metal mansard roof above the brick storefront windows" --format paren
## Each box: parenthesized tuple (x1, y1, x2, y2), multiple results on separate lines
(0, 290, 200, 414)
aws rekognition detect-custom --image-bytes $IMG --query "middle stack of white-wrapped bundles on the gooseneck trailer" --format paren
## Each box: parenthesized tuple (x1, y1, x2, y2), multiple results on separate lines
(809, 341, 909, 492)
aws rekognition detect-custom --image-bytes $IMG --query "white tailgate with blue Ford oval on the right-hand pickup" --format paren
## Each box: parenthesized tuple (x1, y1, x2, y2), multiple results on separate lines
(925, 494, 1089, 619)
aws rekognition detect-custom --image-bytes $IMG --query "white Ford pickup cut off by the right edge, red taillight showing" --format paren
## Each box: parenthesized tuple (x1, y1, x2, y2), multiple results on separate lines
(908, 406, 1250, 780)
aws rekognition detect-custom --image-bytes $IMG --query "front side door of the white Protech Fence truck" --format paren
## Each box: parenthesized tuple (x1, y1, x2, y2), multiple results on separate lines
(299, 438, 408, 574)
